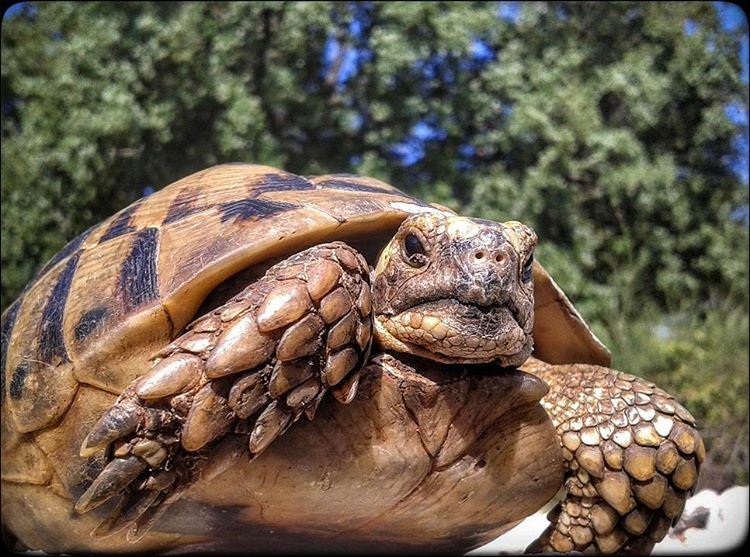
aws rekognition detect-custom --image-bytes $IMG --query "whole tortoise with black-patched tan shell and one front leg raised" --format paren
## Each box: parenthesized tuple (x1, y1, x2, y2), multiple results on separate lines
(1, 164, 705, 553)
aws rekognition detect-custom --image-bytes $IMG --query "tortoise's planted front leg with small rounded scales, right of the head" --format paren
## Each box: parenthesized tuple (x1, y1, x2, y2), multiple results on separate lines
(521, 358, 705, 555)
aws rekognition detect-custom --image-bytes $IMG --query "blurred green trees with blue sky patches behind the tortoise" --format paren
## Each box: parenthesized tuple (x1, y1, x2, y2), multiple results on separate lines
(2, 2, 749, 490)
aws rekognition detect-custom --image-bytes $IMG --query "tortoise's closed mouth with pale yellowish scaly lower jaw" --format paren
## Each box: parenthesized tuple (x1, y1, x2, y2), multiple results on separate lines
(377, 298, 532, 366)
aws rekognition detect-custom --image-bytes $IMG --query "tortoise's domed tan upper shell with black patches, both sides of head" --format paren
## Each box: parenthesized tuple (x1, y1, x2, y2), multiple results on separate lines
(1, 164, 609, 437)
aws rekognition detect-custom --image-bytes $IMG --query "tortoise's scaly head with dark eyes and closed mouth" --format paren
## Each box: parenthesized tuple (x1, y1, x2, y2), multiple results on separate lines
(373, 212, 537, 366)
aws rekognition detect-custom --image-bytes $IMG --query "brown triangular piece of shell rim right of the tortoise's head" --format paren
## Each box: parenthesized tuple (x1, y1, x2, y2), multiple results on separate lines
(532, 261, 612, 367)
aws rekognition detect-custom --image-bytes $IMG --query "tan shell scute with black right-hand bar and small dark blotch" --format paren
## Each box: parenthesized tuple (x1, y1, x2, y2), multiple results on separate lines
(62, 227, 173, 393)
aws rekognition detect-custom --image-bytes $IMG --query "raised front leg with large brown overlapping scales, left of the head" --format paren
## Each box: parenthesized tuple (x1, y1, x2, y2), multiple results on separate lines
(76, 242, 372, 542)
